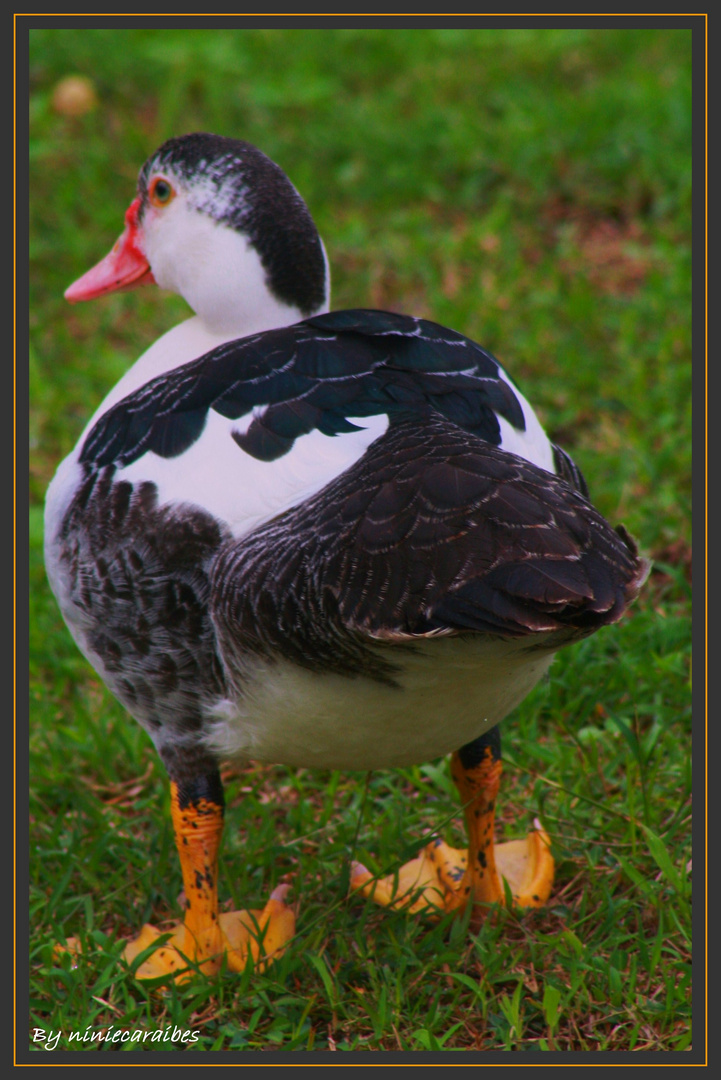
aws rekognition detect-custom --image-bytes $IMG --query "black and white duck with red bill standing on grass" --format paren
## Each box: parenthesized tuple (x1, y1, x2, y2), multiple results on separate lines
(45, 133, 649, 978)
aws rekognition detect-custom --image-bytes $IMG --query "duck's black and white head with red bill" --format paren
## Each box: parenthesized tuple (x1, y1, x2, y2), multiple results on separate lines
(65, 134, 329, 334)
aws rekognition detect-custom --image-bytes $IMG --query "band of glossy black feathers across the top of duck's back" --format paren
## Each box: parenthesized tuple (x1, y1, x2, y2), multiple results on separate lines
(81, 310, 526, 468)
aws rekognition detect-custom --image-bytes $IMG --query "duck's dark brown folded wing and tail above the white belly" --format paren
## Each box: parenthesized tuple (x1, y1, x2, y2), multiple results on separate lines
(212, 414, 647, 677)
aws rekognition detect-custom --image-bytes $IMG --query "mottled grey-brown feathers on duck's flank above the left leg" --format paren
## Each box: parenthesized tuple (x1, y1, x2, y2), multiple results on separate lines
(60, 467, 228, 779)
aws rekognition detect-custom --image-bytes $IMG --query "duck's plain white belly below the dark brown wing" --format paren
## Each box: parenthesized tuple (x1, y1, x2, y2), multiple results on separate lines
(207, 636, 554, 770)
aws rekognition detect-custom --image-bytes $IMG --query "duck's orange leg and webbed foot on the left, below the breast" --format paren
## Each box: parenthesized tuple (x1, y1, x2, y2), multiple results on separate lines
(124, 769, 295, 978)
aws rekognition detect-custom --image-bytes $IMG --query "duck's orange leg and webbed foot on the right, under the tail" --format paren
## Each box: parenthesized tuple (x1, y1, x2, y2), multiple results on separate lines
(351, 727, 554, 923)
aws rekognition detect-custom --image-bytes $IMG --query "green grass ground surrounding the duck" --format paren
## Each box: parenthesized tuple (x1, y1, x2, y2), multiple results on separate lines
(29, 28, 691, 1053)
